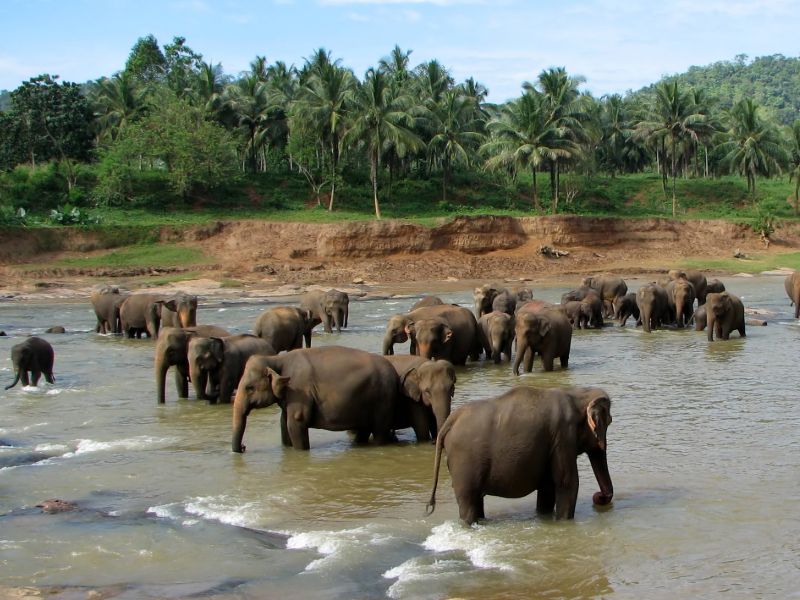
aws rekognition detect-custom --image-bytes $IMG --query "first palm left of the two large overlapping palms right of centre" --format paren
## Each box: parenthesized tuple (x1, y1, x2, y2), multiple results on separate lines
(427, 89, 484, 201)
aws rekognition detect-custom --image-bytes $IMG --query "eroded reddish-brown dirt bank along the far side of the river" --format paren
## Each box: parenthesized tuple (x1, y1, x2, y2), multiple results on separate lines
(0, 216, 800, 299)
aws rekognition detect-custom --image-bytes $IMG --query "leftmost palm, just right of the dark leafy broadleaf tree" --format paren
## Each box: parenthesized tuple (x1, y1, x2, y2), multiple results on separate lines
(90, 71, 147, 140)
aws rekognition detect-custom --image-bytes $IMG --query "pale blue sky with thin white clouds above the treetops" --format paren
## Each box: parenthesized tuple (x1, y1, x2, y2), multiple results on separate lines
(0, 0, 800, 102)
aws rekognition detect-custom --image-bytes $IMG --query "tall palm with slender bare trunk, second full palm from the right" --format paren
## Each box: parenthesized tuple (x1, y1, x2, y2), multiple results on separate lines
(636, 81, 714, 217)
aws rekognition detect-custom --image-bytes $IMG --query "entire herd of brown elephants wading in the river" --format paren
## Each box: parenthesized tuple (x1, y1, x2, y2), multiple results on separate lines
(6, 270, 800, 524)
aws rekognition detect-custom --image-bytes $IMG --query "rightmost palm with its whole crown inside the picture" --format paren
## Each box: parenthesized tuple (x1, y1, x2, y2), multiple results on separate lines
(717, 98, 789, 201)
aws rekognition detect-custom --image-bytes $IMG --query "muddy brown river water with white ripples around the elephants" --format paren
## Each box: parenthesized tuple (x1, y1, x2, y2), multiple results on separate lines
(0, 276, 800, 599)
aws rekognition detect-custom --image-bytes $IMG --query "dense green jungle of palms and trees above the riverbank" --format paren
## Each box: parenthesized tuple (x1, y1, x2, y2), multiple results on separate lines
(0, 35, 800, 229)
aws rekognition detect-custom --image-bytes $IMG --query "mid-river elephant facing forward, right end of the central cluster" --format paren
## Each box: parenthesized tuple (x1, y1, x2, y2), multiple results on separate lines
(514, 307, 572, 375)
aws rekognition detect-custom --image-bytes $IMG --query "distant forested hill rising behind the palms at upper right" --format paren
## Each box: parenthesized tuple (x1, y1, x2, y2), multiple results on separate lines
(633, 54, 800, 125)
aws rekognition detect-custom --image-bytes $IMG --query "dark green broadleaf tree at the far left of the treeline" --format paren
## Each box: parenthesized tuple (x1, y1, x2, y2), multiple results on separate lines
(11, 75, 92, 189)
